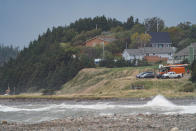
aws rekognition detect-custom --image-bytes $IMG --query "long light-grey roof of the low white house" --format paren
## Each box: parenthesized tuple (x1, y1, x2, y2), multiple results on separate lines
(124, 47, 176, 55)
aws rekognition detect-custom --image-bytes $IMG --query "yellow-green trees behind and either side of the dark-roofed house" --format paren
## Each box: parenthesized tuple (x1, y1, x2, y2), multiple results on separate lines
(108, 17, 196, 51)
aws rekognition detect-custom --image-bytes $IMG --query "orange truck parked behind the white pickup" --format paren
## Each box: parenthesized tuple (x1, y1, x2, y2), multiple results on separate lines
(159, 64, 188, 75)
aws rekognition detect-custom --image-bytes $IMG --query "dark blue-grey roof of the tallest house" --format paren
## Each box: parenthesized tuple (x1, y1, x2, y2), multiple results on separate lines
(149, 32, 171, 43)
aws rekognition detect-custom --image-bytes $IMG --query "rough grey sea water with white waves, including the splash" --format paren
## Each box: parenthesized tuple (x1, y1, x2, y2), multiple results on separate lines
(0, 95, 196, 123)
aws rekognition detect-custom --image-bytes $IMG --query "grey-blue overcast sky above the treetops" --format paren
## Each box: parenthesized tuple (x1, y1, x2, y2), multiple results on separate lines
(0, 0, 196, 48)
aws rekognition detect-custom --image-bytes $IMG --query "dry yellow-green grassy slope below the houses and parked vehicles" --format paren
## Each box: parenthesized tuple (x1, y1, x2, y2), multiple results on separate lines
(57, 67, 196, 98)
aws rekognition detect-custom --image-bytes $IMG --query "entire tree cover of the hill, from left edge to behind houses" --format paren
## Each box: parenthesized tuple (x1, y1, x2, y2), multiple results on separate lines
(0, 16, 196, 94)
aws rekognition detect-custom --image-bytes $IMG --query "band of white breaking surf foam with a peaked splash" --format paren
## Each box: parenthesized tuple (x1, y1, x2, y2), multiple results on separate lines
(0, 95, 196, 114)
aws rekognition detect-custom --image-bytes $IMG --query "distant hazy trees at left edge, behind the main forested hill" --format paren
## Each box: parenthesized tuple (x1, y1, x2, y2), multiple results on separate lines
(0, 44, 19, 66)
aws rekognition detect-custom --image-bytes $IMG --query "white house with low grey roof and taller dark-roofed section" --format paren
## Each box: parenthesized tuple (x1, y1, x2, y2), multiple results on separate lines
(122, 32, 176, 62)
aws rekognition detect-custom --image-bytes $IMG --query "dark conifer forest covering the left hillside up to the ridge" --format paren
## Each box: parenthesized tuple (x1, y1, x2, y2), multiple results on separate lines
(0, 16, 138, 94)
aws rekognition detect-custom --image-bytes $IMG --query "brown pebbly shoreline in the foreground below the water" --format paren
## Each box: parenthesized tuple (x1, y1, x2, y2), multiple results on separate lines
(0, 114, 196, 131)
